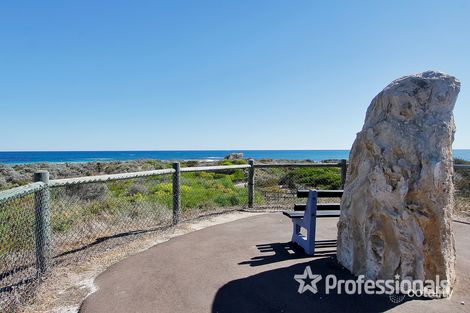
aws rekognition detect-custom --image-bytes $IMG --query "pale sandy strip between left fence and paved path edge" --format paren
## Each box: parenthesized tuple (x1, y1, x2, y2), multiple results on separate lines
(18, 211, 257, 313)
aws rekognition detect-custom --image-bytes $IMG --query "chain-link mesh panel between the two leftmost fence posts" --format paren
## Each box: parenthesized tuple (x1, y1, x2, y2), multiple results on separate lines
(51, 174, 172, 258)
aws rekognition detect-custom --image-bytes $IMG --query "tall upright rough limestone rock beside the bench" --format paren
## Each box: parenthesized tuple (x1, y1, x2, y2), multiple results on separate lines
(338, 71, 460, 292)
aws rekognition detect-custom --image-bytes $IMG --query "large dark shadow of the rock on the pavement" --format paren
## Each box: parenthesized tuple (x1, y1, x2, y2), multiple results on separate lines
(212, 257, 408, 313)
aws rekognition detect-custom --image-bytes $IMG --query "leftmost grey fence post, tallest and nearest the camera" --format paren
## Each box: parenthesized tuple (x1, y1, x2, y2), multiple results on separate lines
(33, 171, 51, 276)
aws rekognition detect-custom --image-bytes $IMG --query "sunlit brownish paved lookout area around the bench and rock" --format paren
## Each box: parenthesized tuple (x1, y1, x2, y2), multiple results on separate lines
(81, 213, 470, 313)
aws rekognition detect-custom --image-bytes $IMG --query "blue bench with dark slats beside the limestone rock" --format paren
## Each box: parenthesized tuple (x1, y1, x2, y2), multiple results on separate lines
(282, 190, 343, 255)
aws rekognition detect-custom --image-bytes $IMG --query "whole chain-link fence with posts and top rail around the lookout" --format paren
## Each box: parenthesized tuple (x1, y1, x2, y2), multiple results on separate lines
(0, 160, 470, 311)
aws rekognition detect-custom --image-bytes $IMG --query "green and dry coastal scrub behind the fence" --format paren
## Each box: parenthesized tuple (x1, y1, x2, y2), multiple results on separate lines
(0, 159, 470, 259)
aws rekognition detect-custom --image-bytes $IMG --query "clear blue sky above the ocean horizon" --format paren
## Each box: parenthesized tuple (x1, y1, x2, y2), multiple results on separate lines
(0, 0, 470, 150)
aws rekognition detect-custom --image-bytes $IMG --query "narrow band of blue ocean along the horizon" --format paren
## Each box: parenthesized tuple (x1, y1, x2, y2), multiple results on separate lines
(0, 149, 470, 164)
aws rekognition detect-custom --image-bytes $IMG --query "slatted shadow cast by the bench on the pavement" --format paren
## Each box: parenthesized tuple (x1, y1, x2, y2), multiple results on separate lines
(238, 240, 336, 266)
